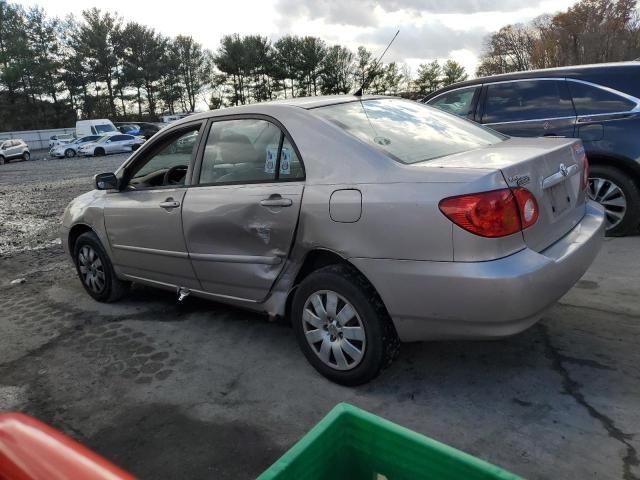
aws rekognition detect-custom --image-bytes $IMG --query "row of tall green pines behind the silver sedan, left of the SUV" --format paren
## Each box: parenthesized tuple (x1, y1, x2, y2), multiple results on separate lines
(0, 0, 466, 130)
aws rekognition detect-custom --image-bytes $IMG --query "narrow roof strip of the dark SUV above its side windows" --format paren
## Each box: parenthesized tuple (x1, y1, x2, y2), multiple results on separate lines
(423, 61, 640, 100)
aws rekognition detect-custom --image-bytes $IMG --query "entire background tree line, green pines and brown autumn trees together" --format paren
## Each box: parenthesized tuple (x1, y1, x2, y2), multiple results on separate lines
(0, 0, 640, 130)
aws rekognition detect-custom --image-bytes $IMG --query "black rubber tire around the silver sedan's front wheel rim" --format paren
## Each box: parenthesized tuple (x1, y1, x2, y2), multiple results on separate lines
(73, 232, 130, 303)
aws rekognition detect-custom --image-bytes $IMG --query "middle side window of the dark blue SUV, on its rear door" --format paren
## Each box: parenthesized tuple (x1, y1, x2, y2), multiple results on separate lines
(482, 80, 575, 123)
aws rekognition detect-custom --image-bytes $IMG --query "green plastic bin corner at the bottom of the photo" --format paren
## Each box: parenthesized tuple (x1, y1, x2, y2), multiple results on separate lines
(258, 403, 522, 480)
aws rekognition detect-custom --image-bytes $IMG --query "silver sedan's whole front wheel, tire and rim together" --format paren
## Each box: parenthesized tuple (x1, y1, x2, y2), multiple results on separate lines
(73, 232, 129, 302)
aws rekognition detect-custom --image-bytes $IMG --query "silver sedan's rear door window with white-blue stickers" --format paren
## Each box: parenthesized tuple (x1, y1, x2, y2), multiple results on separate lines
(200, 119, 304, 184)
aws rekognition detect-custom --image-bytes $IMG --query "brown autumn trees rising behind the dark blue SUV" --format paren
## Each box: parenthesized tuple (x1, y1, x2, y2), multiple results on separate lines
(476, 0, 640, 76)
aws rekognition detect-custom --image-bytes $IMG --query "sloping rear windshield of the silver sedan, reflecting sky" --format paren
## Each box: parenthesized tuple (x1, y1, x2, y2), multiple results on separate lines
(312, 99, 507, 163)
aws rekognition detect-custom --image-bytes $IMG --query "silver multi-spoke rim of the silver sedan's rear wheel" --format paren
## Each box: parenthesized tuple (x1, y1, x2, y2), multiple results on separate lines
(302, 290, 366, 370)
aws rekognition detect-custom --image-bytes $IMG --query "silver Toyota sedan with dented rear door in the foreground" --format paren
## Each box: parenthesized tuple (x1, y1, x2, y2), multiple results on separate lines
(62, 96, 604, 385)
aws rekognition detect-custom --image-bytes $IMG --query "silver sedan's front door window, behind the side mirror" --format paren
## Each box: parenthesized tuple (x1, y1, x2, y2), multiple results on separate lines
(122, 125, 200, 190)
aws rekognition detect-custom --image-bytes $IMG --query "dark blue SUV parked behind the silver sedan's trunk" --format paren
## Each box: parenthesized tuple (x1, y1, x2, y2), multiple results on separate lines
(422, 62, 640, 235)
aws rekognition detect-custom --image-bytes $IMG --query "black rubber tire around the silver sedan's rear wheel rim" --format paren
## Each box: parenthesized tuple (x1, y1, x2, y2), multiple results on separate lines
(291, 265, 400, 386)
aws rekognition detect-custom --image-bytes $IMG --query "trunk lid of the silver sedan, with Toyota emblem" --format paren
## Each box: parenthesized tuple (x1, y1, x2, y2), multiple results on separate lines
(424, 138, 586, 252)
